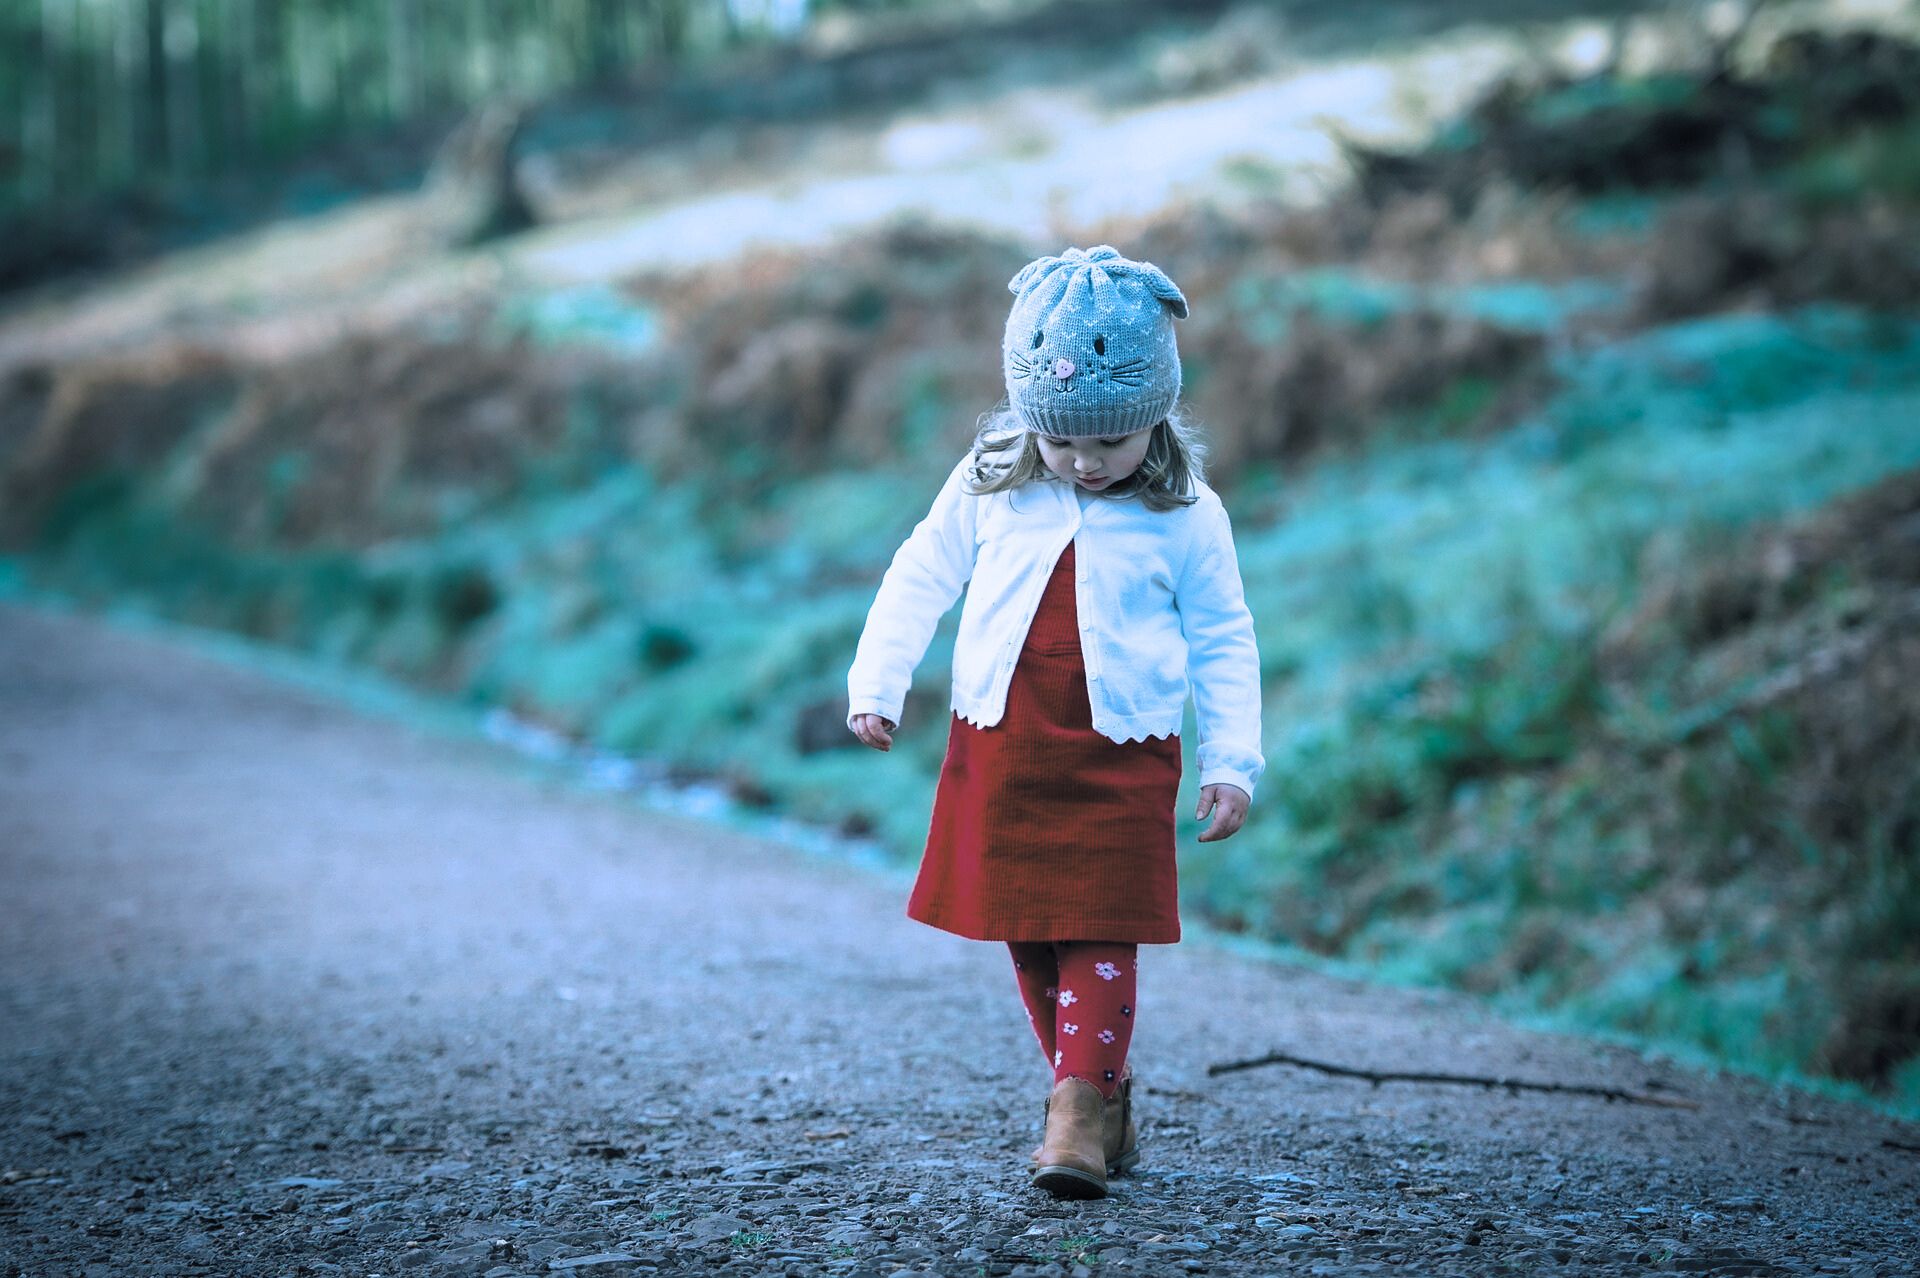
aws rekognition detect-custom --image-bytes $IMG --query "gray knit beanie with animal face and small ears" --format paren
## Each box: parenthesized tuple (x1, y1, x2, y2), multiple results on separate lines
(1000, 244, 1187, 438)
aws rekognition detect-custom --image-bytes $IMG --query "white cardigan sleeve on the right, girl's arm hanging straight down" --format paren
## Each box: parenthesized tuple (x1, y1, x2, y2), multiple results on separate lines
(1173, 497, 1267, 798)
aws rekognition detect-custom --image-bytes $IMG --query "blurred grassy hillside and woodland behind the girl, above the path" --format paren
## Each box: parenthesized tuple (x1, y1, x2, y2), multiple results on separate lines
(0, 0, 1920, 1113)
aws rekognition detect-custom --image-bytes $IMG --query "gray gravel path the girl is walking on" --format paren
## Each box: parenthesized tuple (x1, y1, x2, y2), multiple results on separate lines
(0, 608, 1920, 1278)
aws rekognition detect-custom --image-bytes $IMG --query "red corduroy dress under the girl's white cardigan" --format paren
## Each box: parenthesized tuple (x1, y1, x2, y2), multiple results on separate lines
(906, 543, 1181, 944)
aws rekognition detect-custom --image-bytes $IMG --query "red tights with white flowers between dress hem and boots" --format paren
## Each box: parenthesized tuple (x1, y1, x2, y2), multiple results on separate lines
(1006, 940, 1140, 1098)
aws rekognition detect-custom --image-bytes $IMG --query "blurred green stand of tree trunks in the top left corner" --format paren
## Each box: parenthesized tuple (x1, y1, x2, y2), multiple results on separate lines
(0, 0, 821, 205)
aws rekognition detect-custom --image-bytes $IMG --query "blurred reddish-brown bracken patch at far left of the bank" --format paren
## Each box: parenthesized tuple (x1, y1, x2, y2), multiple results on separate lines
(4, 334, 599, 547)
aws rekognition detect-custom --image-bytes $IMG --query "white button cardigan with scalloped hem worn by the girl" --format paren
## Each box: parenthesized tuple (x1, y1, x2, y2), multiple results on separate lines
(847, 453, 1265, 796)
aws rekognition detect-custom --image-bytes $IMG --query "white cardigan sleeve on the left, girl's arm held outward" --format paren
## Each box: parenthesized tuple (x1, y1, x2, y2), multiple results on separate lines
(847, 449, 979, 727)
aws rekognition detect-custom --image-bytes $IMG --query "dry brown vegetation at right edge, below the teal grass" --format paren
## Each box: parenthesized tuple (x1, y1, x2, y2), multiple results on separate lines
(1599, 472, 1920, 1084)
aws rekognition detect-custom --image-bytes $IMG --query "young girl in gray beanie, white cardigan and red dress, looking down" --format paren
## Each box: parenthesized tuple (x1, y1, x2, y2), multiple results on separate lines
(847, 246, 1265, 1197)
